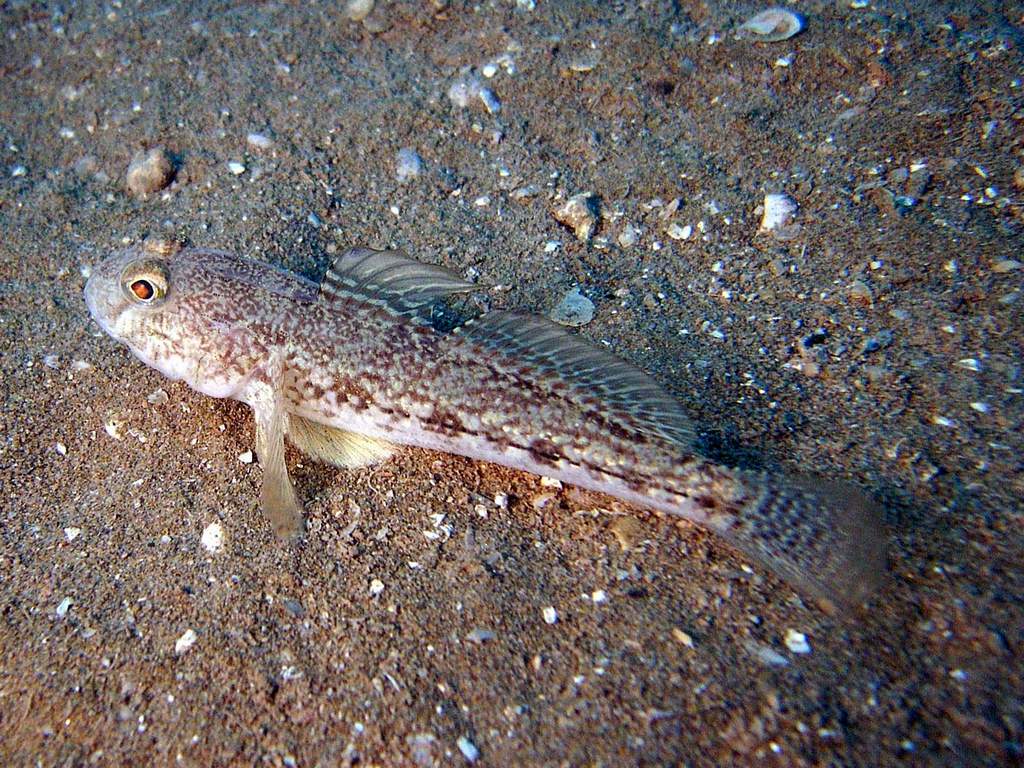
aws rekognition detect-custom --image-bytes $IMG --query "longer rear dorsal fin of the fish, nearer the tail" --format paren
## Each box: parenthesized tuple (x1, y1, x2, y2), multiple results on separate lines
(454, 311, 696, 450)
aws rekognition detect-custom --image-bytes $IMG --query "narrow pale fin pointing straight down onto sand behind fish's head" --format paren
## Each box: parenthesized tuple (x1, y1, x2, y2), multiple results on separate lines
(253, 394, 302, 539)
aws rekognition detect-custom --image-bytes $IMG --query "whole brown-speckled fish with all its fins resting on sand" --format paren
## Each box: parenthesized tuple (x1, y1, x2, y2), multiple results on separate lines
(85, 243, 885, 603)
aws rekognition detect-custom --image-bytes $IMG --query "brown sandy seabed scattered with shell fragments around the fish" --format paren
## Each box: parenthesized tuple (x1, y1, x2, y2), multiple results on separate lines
(0, 0, 1024, 766)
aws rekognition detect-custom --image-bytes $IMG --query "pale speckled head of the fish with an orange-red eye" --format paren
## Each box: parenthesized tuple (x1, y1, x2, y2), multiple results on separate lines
(85, 247, 315, 397)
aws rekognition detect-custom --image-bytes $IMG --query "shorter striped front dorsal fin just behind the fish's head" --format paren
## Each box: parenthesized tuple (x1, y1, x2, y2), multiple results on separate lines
(321, 248, 477, 316)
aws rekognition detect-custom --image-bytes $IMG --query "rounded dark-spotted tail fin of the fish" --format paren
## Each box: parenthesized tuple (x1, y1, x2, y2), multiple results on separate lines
(713, 472, 886, 607)
